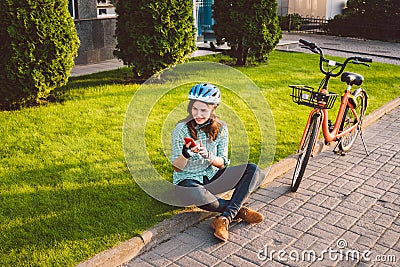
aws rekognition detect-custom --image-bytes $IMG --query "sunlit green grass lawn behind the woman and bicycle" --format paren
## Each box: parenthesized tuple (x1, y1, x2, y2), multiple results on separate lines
(0, 51, 400, 266)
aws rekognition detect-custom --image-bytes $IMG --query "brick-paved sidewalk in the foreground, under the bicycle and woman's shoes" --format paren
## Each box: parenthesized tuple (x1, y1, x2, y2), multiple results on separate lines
(123, 106, 400, 267)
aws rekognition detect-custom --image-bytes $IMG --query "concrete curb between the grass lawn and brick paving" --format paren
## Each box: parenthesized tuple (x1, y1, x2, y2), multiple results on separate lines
(77, 97, 400, 267)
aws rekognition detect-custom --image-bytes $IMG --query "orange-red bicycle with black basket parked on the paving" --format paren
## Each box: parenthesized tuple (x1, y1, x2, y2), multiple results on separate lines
(289, 39, 372, 192)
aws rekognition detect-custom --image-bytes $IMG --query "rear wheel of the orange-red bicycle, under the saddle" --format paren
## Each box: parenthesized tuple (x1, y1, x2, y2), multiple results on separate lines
(339, 90, 367, 152)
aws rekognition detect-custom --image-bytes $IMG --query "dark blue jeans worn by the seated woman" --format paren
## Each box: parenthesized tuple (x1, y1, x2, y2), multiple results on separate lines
(178, 163, 265, 221)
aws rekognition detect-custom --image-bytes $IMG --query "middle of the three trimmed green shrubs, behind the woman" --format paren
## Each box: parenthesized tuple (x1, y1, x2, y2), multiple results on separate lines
(114, 0, 196, 78)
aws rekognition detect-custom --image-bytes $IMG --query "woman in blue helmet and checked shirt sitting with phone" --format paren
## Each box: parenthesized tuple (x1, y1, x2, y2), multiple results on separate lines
(171, 84, 265, 241)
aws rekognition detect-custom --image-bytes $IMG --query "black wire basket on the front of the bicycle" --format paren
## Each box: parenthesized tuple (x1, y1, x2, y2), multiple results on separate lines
(289, 85, 338, 109)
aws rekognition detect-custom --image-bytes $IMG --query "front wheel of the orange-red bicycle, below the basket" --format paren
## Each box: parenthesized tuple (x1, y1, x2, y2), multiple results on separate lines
(290, 114, 321, 192)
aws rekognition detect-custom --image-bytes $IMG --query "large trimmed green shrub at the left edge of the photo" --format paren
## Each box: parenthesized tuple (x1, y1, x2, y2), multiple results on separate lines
(0, 0, 79, 109)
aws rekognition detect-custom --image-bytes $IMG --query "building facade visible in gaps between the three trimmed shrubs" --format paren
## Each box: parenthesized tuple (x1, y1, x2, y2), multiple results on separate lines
(68, 0, 209, 65)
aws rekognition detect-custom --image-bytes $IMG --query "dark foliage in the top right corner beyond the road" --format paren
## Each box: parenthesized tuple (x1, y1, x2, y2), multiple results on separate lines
(328, 0, 400, 41)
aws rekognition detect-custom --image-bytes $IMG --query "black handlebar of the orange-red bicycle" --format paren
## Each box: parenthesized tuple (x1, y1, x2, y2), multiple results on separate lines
(299, 39, 372, 77)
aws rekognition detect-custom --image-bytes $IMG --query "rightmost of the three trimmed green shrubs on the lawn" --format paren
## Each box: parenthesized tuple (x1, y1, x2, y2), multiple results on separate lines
(213, 0, 282, 65)
